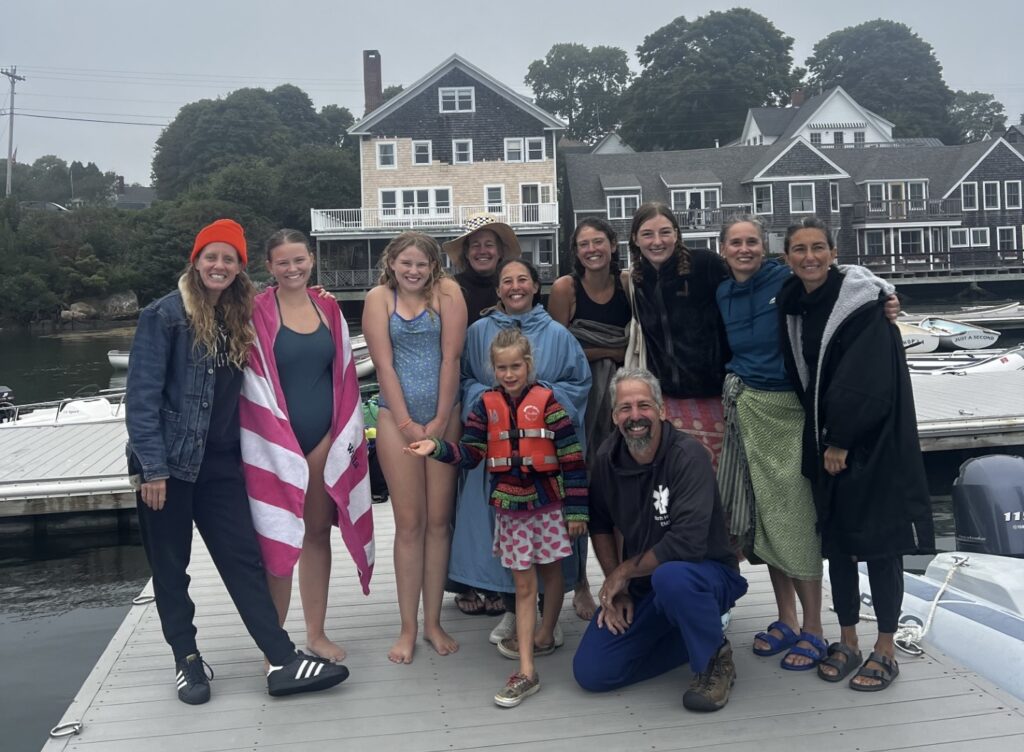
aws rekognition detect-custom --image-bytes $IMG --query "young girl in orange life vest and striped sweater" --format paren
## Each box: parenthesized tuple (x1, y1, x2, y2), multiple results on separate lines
(407, 329, 589, 708)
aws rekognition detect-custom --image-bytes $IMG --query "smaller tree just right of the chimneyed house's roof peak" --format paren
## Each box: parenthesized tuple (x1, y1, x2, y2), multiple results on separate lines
(524, 43, 633, 142)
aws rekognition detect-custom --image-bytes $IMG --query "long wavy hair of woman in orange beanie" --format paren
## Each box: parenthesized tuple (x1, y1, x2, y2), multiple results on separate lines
(178, 263, 256, 368)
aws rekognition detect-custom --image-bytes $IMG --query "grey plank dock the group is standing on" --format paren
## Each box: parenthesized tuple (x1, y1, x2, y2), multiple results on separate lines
(37, 504, 1024, 752)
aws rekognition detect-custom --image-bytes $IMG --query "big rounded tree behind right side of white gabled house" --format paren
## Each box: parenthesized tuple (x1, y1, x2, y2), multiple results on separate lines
(807, 18, 958, 142)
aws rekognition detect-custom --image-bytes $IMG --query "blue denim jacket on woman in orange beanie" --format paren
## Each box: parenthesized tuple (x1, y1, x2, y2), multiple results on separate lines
(125, 291, 216, 482)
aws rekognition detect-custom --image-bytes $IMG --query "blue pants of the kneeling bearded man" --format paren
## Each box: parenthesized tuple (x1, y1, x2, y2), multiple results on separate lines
(572, 561, 746, 692)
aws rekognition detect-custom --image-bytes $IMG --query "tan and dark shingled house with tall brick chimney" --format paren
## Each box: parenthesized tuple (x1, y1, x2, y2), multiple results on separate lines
(310, 50, 565, 290)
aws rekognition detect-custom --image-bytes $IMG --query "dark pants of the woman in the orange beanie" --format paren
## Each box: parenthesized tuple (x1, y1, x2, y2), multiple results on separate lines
(136, 452, 295, 666)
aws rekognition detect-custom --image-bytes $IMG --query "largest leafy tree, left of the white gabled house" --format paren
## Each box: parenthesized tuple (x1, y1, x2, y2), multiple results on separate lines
(621, 8, 804, 151)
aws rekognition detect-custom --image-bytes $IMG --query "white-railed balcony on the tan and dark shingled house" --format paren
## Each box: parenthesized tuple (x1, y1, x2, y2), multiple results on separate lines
(309, 202, 558, 238)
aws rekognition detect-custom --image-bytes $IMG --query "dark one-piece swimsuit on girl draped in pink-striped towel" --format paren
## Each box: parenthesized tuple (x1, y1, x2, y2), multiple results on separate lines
(273, 298, 335, 455)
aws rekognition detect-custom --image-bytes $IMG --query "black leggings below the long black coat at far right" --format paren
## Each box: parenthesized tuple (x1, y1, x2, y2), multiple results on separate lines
(828, 556, 903, 634)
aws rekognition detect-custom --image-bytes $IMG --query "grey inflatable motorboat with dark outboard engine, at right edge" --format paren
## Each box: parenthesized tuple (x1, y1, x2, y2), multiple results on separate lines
(847, 455, 1024, 700)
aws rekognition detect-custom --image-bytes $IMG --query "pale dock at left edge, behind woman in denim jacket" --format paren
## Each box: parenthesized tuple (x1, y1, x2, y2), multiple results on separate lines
(0, 419, 135, 517)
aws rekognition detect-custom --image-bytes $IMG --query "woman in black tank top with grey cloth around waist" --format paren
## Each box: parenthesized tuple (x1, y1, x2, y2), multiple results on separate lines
(548, 217, 631, 619)
